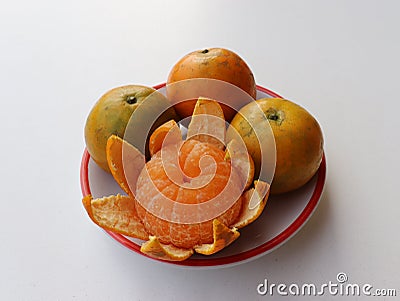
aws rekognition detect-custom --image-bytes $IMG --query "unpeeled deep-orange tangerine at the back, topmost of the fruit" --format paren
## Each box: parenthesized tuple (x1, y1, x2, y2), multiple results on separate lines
(167, 48, 257, 122)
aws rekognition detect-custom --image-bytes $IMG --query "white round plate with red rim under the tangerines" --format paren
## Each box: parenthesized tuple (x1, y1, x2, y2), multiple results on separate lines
(80, 84, 326, 268)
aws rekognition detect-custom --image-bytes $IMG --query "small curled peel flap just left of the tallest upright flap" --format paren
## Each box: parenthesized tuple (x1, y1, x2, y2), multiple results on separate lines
(149, 120, 182, 156)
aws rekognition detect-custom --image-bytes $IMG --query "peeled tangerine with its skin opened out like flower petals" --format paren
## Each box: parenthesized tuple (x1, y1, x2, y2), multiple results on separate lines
(83, 98, 269, 261)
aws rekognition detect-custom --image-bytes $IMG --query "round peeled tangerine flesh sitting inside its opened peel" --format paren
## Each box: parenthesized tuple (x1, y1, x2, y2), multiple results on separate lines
(135, 139, 241, 248)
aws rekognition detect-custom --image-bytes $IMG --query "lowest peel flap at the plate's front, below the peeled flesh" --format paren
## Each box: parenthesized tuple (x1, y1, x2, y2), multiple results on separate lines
(140, 236, 193, 261)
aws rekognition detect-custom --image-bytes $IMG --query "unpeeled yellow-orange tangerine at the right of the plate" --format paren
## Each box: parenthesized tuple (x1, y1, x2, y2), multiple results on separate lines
(227, 98, 323, 194)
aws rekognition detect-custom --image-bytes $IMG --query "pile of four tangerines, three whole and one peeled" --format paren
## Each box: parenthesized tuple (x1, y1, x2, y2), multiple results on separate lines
(83, 48, 323, 261)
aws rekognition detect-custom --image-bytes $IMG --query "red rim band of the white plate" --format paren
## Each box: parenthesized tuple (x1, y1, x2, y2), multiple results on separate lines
(80, 83, 326, 267)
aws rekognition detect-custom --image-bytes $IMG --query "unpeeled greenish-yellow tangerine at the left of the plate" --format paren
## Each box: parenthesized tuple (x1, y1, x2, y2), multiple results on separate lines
(85, 85, 177, 172)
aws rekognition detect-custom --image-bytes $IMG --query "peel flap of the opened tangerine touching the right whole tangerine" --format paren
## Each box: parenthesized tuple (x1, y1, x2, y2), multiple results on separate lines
(225, 140, 254, 190)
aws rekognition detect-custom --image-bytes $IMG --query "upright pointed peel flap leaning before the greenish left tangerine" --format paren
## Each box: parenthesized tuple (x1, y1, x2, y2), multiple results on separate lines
(106, 135, 145, 196)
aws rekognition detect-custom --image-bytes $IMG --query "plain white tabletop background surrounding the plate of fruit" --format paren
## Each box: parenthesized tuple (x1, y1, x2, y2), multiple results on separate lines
(0, 0, 400, 300)
